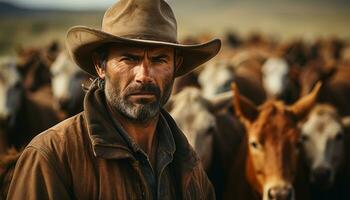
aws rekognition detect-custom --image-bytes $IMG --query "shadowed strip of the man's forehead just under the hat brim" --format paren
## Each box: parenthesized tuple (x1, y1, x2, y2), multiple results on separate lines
(108, 44, 174, 56)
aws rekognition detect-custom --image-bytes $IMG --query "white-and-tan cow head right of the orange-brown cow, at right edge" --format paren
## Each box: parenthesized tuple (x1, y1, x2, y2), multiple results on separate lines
(301, 104, 350, 190)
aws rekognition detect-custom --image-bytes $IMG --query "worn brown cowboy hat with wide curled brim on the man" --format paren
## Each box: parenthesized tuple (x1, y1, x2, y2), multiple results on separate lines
(66, 0, 221, 76)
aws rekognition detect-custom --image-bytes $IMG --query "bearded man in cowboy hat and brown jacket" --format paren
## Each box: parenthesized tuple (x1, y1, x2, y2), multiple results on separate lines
(8, 0, 220, 200)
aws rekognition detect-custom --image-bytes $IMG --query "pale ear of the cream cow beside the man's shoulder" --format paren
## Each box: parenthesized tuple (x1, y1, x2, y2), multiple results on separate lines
(208, 91, 232, 113)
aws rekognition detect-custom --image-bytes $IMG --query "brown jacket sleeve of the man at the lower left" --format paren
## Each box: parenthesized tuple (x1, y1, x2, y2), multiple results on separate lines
(7, 147, 71, 200)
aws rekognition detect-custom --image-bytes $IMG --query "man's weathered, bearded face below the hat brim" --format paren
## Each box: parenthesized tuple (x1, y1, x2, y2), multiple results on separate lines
(99, 43, 174, 122)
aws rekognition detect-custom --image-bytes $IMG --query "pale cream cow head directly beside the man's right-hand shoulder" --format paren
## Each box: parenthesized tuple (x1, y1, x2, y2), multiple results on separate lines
(167, 87, 232, 169)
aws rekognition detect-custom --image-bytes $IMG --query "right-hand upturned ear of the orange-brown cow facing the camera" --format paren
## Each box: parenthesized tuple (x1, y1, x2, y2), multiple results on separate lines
(287, 82, 322, 119)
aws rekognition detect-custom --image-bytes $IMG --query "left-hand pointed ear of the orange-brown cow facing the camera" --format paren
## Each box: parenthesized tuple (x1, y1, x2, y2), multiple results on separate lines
(231, 83, 258, 123)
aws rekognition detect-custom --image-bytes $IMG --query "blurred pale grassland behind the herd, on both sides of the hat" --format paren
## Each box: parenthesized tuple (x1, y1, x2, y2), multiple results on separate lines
(0, 0, 350, 54)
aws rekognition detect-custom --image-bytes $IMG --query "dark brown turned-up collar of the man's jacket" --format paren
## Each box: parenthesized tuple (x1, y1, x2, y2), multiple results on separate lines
(84, 85, 199, 166)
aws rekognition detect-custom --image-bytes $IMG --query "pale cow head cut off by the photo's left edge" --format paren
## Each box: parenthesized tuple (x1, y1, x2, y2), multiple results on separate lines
(0, 58, 23, 129)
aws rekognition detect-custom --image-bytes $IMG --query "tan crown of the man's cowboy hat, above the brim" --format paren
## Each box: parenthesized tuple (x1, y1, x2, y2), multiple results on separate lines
(102, 0, 177, 43)
